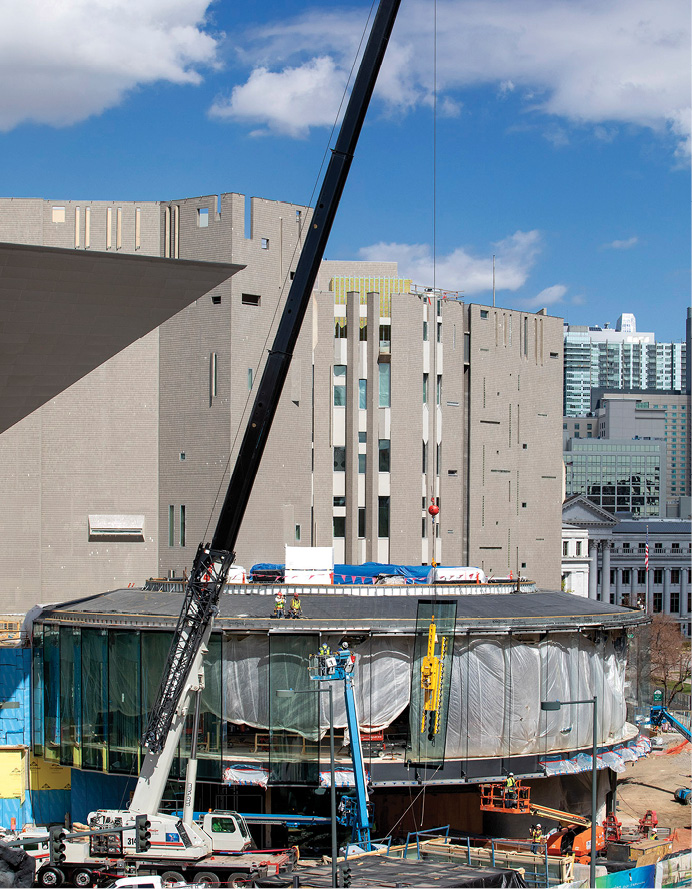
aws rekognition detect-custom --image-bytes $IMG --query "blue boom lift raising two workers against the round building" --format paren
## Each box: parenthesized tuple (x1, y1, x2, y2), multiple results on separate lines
(308, 644, 379, 854)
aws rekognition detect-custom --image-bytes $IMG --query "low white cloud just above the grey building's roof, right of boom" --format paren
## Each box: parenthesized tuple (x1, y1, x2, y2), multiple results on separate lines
(358, 231, 541, 296)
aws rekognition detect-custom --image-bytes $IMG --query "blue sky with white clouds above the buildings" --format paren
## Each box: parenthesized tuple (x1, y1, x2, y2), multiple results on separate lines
(0, 0, 690, 340)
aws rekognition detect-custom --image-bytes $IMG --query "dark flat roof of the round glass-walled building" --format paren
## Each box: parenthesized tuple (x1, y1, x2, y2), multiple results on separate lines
(39, 585, 648, 634)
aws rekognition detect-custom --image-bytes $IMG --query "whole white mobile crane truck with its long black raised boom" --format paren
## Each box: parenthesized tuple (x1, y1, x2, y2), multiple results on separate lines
(35, 0, 400, 885)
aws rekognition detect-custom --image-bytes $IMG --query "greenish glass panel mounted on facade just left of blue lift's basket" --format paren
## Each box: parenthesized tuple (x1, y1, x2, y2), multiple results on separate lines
(270, 633, 321, 784)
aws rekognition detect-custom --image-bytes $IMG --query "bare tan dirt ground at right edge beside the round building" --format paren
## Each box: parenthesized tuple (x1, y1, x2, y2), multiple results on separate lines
(617, 734, 692, 849)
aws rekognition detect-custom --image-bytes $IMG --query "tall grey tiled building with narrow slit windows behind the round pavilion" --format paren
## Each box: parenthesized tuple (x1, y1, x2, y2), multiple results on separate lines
(0, 194, 562, 613)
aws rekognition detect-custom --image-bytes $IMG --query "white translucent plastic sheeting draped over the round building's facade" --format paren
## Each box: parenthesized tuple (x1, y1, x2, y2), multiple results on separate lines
(223, 632, 627, 758)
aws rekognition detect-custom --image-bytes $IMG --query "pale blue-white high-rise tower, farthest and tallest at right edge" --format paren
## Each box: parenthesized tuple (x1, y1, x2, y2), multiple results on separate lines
(563, 314, 687, 417)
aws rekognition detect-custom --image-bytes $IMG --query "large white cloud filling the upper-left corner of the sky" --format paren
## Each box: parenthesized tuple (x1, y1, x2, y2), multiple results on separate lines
(0, 0, 217, 131)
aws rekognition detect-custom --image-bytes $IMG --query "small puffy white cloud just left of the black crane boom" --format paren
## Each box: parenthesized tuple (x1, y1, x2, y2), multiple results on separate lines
(209, 56, 346, 136)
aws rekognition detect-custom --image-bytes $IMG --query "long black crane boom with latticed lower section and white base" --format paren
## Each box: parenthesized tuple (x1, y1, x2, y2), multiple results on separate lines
(131, 0, 400, 812)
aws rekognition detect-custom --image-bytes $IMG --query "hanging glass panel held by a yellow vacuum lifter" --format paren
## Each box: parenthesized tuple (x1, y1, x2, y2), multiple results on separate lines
(407, 599, 457, 765)
